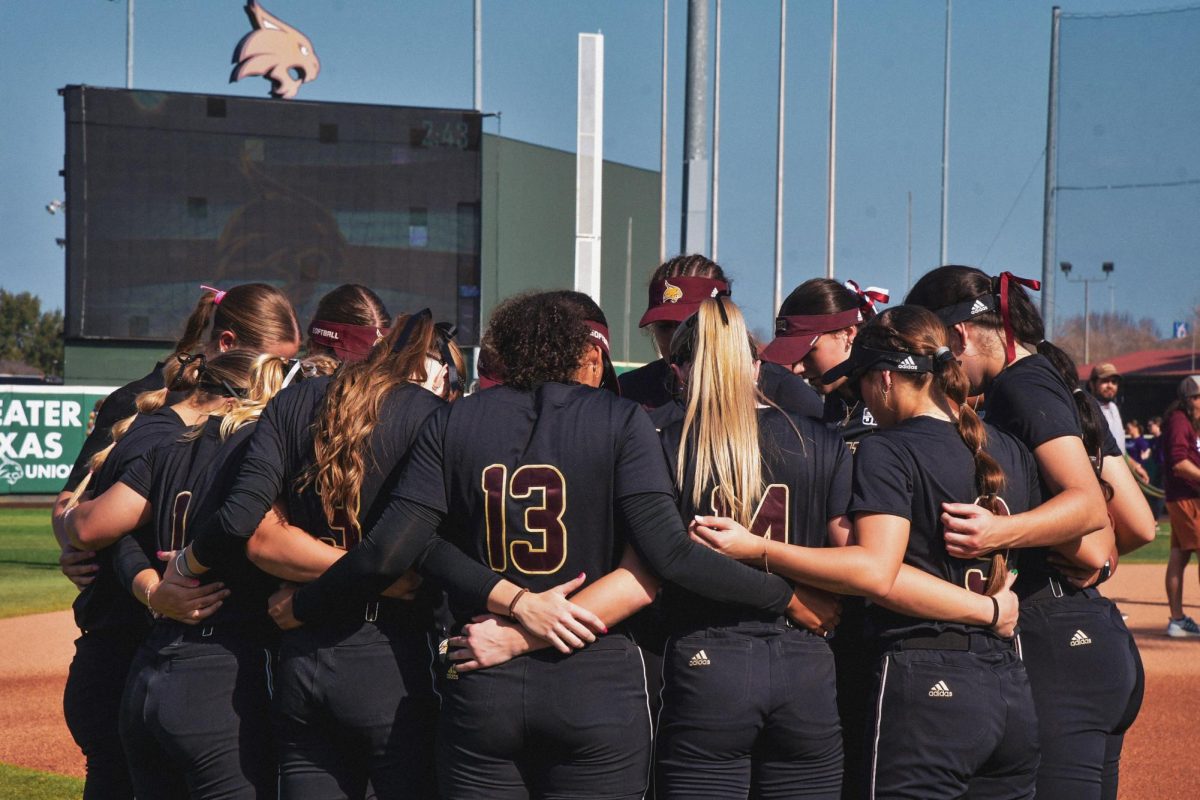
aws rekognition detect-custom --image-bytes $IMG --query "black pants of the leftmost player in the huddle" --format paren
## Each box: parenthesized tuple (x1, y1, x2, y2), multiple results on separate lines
(62, 625, 146, 800)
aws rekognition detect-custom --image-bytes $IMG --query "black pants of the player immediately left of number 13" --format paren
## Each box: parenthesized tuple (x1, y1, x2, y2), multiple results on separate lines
(275, 618, 438, 800)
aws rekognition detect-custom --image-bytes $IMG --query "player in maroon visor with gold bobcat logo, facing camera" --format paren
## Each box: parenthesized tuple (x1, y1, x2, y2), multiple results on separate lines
(619, 255, 823, 420)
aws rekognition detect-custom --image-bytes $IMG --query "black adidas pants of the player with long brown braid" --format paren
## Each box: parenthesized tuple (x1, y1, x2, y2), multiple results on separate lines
(868, 633, 1036, 800)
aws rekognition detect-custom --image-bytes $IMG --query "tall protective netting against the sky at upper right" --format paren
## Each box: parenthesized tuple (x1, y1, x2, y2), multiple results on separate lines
(1055, 6, 1200, 333)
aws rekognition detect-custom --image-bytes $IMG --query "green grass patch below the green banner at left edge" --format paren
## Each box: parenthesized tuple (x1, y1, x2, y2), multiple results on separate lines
(0, 509, 78, 623)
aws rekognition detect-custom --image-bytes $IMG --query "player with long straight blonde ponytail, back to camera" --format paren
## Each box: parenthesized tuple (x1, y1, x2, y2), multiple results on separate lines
(655, 296, 851, 798)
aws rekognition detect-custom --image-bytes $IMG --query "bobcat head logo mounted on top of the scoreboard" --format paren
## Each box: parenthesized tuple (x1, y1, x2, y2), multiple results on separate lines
(229, 0, 320, 100)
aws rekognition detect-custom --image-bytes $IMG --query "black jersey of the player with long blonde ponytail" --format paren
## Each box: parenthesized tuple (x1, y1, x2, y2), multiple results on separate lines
(659, 408, 852, 630)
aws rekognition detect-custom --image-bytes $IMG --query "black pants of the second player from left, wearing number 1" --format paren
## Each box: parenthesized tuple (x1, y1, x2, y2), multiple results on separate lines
(120, 621, 276, 800)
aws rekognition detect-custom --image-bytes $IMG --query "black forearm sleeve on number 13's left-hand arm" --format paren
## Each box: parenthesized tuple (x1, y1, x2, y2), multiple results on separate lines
(292, 499, 442, 622)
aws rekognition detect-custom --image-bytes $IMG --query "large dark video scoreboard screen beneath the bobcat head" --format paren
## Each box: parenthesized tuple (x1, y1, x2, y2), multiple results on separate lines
(64, 86, 481, 344)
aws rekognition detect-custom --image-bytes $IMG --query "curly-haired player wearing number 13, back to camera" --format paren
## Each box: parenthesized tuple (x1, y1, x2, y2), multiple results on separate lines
(279, 293, 791, 798)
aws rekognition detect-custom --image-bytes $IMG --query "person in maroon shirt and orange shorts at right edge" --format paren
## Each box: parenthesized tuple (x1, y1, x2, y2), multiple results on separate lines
(1162, 375, 1200, 637)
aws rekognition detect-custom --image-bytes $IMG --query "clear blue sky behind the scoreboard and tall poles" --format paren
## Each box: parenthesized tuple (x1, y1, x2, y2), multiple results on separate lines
(0, 0, 1200, 333)
